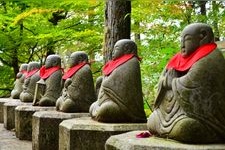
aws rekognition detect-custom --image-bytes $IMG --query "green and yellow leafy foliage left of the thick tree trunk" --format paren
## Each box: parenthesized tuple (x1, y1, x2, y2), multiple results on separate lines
(0, 1, 103, 96)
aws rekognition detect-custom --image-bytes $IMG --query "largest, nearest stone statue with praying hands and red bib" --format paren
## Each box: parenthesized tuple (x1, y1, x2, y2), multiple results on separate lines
(147, 23, 225, 144)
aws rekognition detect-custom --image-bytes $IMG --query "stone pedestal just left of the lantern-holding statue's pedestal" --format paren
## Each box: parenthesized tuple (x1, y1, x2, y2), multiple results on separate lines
(3, 100, 32, 130)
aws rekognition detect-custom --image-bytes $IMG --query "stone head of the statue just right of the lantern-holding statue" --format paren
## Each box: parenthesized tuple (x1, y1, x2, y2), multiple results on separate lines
(68, 51, 88, 67)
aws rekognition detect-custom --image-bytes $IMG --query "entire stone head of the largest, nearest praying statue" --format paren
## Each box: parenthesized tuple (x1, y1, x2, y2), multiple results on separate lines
(181, 23, 214, 57)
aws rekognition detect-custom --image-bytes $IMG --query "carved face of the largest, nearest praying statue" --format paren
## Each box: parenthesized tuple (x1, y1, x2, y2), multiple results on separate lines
(181, 34, 200, 57)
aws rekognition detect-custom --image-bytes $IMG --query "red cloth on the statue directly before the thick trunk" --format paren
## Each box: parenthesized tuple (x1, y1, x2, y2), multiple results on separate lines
(103, 54, 135, 76)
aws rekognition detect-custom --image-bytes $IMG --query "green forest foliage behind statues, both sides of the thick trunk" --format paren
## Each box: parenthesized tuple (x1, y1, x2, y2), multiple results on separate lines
(0, 0, 225, 115)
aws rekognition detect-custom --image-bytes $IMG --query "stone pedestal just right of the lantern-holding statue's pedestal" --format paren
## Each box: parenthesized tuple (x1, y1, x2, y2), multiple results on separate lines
(32, 111, 89, 150)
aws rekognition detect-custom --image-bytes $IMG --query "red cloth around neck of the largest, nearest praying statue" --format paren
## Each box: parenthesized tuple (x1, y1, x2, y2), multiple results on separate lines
(166, 43, 217, 71)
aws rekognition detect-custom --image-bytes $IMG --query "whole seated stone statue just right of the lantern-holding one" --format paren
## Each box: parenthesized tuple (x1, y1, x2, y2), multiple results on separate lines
(56, 51, 96, 112)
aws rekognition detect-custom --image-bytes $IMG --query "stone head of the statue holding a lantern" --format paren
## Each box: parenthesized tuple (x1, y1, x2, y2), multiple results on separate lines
(45, 54, 61, 69)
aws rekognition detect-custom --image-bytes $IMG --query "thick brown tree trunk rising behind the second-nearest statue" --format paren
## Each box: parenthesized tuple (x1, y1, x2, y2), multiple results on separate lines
(103, 0, 131, 63)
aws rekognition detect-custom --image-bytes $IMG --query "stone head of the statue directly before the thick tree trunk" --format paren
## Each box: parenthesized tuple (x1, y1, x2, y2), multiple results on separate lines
(112, 39, 137, 59)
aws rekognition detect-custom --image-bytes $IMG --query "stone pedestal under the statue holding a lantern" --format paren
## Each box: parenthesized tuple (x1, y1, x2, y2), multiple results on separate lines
(15, 106, 55, 140)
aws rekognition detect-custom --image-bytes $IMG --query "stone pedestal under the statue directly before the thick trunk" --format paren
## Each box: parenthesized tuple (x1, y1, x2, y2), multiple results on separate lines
(59, 117, 147, 150)
